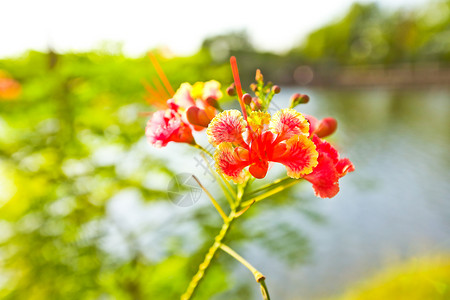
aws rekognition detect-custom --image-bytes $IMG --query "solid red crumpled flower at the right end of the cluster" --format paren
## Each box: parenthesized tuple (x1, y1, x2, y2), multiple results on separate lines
(303, 134, 355, 198)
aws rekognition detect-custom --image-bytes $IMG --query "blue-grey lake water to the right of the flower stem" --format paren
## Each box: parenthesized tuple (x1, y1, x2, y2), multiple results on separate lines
(246, 89, 450, 299)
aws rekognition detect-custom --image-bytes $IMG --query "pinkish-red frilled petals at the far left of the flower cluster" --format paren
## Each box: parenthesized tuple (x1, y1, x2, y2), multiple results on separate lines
(145, 105, 195, 147)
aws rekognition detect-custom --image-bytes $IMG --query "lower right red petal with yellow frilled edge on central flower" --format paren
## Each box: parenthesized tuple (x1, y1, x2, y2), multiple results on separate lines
(270, 135, 319, 179)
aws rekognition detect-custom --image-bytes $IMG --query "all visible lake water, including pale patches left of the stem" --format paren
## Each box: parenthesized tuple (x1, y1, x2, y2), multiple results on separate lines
(106, 88, 450, 299)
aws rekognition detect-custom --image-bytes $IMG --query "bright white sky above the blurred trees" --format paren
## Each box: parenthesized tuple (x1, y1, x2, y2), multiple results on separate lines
(0, 0, 428, 57)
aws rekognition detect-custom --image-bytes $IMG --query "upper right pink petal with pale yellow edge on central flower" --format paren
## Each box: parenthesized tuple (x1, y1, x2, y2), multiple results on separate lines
(269, 108, 309, 141)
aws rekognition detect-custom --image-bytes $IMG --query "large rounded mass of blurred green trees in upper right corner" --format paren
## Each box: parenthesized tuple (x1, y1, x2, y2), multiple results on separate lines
(293, 0, 450, 65)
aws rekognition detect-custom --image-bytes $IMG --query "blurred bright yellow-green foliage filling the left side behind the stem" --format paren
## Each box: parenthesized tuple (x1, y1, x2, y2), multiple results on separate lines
(0, 48, 318, 299)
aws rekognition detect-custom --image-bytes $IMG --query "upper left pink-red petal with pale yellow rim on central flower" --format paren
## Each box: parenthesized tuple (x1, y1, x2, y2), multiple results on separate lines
(206, 109, 246, 146)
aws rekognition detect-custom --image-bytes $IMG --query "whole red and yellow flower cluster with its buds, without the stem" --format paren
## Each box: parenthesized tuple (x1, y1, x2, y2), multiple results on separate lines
(146, 57, 354, 198)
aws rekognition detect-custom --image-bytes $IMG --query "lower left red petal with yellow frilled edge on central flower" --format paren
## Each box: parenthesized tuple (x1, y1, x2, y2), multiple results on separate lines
(214, 142, 250, 183)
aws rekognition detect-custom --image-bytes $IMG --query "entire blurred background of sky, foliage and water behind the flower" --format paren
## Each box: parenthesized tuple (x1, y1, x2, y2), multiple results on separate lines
(0, 0, 450, 300)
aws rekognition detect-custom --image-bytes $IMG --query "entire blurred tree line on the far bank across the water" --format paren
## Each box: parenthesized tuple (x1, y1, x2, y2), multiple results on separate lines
(202, 0, 450, 84)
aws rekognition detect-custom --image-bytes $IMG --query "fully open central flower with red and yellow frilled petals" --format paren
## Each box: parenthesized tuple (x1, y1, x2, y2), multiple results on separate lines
(206, 109, 318, 182)
